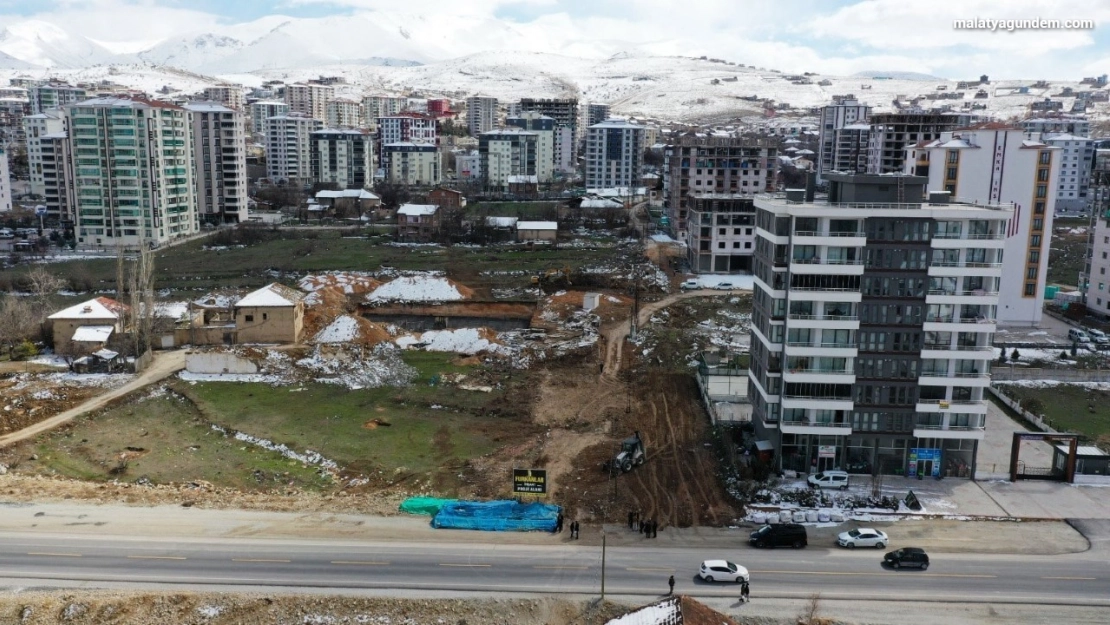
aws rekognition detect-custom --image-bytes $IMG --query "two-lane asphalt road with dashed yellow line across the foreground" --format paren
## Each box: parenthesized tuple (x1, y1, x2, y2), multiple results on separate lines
(0, 533, 1110, 607)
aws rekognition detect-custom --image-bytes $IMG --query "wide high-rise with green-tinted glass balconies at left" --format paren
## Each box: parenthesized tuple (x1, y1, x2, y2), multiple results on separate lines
(65, 98, 200, 248)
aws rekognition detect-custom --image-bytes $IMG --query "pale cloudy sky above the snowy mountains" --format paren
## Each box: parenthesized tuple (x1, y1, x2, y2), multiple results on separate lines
(0, 0, 1110, 79)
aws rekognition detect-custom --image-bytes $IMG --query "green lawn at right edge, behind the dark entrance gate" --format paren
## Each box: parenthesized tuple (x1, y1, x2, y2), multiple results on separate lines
(1005, 384, 1110, 443)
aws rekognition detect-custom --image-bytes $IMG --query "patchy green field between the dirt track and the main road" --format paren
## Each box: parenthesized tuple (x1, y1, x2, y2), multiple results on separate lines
(18, 352, 532, 492)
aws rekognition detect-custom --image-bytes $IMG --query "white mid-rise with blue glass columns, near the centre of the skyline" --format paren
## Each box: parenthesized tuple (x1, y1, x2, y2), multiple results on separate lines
(586, 119, 644, 189)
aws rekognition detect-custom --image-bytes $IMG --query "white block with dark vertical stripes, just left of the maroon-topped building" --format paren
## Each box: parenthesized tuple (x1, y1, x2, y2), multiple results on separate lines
(311, 128, 374, 190)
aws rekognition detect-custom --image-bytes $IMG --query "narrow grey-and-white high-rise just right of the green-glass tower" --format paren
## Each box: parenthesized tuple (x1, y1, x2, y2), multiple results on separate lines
(185, 102, 248, 225)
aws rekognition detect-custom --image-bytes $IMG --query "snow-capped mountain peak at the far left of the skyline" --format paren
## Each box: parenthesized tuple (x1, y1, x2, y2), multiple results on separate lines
(0, 20, 129, 69)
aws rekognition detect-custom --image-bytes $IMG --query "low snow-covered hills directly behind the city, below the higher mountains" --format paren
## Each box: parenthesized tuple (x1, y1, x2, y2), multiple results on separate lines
(0, 51, 1110, 122)
